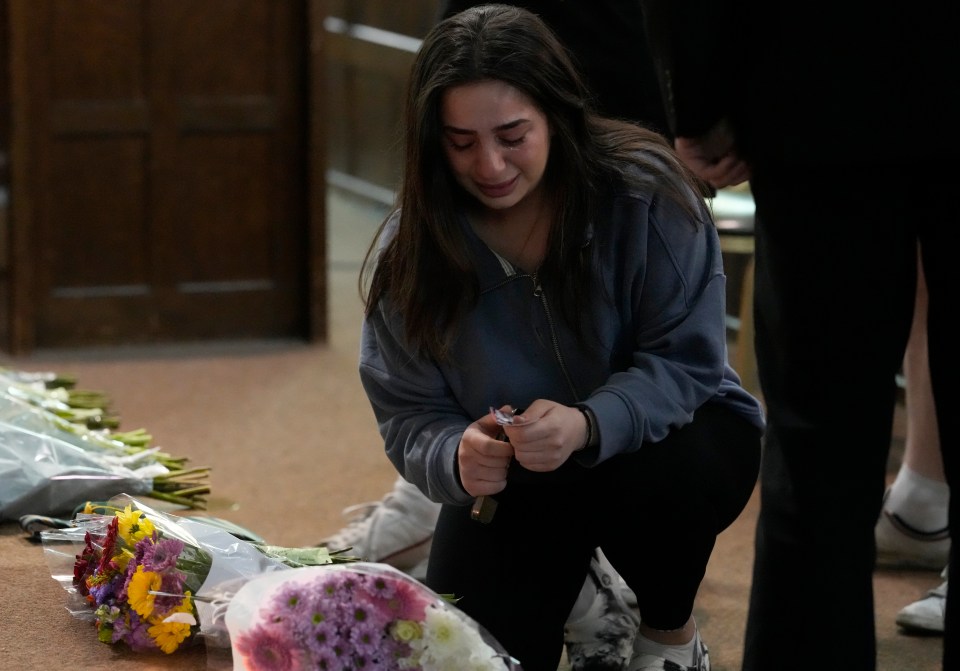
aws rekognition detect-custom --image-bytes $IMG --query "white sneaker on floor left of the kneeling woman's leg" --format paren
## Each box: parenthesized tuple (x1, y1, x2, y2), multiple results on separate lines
(317, 478, 440, 579)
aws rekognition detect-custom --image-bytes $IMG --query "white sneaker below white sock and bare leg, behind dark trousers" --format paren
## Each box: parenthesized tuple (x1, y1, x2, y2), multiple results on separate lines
(874, 490, 950, 571)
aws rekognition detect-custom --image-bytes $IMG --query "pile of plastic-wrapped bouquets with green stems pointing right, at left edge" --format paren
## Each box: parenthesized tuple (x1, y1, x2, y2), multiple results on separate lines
(0, 368, 210, 521)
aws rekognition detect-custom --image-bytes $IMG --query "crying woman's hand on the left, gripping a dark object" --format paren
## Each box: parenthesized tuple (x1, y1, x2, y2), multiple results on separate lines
(457, 414, 513, 496)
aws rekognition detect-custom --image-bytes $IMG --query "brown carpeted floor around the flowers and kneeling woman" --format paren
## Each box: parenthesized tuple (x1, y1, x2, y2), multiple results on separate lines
(0, 186, 942, 671)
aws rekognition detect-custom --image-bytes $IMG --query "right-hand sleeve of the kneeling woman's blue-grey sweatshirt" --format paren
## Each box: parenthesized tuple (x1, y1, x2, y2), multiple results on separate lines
(576, 189, 728, 466)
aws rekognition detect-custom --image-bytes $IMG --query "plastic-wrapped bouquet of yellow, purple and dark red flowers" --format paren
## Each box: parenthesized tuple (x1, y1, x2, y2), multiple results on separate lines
(41, 495, 346, 653)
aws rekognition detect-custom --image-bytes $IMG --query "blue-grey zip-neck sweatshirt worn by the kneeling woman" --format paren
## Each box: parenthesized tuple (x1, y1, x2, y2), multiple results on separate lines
(360, 178, 764, 505)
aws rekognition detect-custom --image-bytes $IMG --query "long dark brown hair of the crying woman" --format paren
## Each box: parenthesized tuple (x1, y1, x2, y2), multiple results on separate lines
(360, 4, 709, 360)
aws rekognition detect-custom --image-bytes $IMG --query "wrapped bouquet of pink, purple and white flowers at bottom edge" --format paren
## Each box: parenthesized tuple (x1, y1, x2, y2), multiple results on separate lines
(226, 562, 520, 671)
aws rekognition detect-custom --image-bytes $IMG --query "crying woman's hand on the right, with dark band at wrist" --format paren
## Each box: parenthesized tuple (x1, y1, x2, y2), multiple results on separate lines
(503, 399, 587, 472)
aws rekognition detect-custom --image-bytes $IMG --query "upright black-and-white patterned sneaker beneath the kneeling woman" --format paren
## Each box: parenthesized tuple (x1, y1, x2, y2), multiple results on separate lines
(563, 548, 640, 671)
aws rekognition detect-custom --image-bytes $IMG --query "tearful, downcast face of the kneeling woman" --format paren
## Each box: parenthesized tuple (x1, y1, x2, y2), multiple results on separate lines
(440, 80, 550, 210)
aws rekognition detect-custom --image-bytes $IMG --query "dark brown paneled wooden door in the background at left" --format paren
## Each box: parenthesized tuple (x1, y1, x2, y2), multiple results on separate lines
(8, 0, 325, 352)
